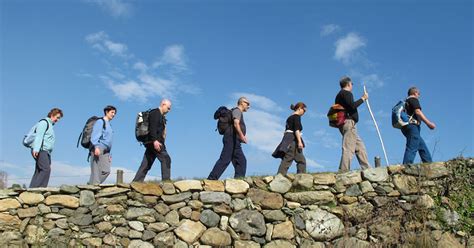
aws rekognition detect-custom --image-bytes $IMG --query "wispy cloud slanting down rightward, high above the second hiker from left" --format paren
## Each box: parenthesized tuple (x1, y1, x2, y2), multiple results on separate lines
(86, 31, 130, 57)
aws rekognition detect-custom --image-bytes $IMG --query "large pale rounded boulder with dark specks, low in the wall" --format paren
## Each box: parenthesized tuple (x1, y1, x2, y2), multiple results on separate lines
(305, 209, 344, 241)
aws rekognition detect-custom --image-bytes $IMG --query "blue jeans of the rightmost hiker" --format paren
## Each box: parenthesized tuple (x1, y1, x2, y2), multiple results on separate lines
(402, 124, 433, 164)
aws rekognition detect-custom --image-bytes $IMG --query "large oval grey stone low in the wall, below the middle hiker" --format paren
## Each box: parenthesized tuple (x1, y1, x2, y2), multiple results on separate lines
(229, 210, 266, 236)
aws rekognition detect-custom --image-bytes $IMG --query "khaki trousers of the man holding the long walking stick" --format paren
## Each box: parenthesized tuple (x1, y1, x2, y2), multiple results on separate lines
(339, 119, 370, 172)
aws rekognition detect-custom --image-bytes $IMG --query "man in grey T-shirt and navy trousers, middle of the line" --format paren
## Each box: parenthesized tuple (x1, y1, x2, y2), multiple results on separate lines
(207, 97, 250, 180)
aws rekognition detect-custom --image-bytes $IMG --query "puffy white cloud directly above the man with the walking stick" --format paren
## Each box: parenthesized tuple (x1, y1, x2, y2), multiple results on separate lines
(334, 33, 366, 64)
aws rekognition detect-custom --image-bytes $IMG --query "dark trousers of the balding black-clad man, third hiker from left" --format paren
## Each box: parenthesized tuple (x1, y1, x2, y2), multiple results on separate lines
(133, 144, 171, 182)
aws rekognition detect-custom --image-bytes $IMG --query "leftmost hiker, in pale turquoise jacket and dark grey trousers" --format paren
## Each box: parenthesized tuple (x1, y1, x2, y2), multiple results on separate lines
(30, 108, 63, 188)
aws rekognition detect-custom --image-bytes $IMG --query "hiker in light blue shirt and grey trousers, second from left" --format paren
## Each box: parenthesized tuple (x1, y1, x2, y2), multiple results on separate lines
(89, 105, 117, 184)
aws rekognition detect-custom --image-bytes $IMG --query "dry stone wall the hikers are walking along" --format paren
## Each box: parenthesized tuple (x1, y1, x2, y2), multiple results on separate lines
(0, 159, 473, 248)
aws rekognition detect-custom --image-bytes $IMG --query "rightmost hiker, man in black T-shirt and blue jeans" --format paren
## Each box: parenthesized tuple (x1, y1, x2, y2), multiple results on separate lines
(401, 87, 436, 164)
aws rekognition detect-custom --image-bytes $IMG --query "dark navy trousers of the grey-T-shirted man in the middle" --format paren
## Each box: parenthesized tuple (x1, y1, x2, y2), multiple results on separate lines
(207, 132, 247, 180)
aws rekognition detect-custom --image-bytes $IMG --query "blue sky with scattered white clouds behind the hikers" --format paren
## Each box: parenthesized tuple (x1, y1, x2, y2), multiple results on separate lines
(0, 0, 474, 186)
